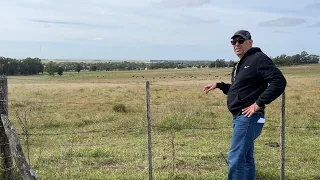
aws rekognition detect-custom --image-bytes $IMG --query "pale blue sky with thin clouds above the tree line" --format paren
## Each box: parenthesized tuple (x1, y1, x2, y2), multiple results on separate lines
(0, 0, 320, 60)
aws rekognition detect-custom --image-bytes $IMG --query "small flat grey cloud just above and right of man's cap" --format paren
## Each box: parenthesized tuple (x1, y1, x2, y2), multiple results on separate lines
(259, 17, 307, 27)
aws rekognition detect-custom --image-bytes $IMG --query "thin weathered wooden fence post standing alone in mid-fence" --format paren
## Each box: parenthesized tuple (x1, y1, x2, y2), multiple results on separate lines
(146, 81, 152, 180)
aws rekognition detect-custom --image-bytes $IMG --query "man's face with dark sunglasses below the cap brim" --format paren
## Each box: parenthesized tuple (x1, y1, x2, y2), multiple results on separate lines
(231, 36, 252, 56)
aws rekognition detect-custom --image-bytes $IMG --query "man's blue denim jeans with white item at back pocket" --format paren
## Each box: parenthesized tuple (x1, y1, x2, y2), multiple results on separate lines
(228, 114, 264, 180)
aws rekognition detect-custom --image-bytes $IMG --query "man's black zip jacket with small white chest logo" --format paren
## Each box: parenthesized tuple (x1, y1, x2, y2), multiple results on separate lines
(217, 47, 287, 118)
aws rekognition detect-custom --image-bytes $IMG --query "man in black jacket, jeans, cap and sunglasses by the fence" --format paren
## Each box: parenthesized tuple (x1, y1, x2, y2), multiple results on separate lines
(204, 30, 287, 180)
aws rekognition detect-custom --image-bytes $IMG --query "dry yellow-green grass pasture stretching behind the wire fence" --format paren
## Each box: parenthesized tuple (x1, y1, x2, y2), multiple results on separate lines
(8, 65, 320, 180)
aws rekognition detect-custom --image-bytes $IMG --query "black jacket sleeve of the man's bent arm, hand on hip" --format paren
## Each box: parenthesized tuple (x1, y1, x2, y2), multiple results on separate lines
(256, 56, 287, 107)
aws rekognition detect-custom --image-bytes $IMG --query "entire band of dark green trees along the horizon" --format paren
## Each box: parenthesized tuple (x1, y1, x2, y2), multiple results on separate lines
(0, 51, 320, 75)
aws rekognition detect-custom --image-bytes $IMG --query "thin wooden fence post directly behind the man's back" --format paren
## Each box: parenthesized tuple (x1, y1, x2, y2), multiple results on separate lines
(280, 92, 286, 180)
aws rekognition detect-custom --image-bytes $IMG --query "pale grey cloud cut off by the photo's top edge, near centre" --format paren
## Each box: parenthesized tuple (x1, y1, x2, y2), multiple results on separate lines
(161, 0, 211, 8)
